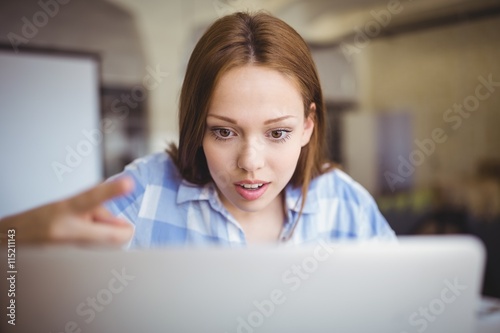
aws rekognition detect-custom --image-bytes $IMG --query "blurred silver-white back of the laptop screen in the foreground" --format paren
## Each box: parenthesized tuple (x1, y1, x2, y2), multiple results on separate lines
(0, 236, 485, 333)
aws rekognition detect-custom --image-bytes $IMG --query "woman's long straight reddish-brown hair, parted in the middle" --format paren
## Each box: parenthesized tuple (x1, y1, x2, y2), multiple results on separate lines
(167, 12, 334, 211)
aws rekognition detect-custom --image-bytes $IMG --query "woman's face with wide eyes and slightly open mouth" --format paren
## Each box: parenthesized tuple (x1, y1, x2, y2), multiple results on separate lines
(203, 65, 315, 213)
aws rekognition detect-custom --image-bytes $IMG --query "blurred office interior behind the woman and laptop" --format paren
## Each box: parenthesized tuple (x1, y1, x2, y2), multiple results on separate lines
(0, 0, 500, 297)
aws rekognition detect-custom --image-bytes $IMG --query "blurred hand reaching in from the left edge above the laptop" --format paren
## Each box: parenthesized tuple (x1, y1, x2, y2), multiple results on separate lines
(0, 178, 134, 245)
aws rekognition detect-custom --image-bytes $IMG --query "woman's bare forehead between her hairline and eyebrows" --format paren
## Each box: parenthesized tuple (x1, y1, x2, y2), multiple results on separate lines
(209, 65, 303, 116)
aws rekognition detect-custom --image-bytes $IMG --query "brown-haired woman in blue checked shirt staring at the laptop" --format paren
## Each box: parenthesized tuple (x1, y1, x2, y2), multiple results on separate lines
(107, 13, 394, 247)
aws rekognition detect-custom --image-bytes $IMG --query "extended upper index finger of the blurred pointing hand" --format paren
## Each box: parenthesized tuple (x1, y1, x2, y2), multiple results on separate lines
(69, 177, 134, 213)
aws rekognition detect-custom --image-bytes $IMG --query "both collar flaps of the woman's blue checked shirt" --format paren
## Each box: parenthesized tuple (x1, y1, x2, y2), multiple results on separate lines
(177, 180, 318, 214)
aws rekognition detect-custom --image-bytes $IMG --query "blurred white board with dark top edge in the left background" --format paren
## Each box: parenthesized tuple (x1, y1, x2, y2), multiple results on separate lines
(0, 50, 102, 217)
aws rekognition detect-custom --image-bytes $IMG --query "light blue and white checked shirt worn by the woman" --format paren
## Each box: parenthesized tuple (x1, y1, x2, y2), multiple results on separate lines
(106, 153, 395, 248)
